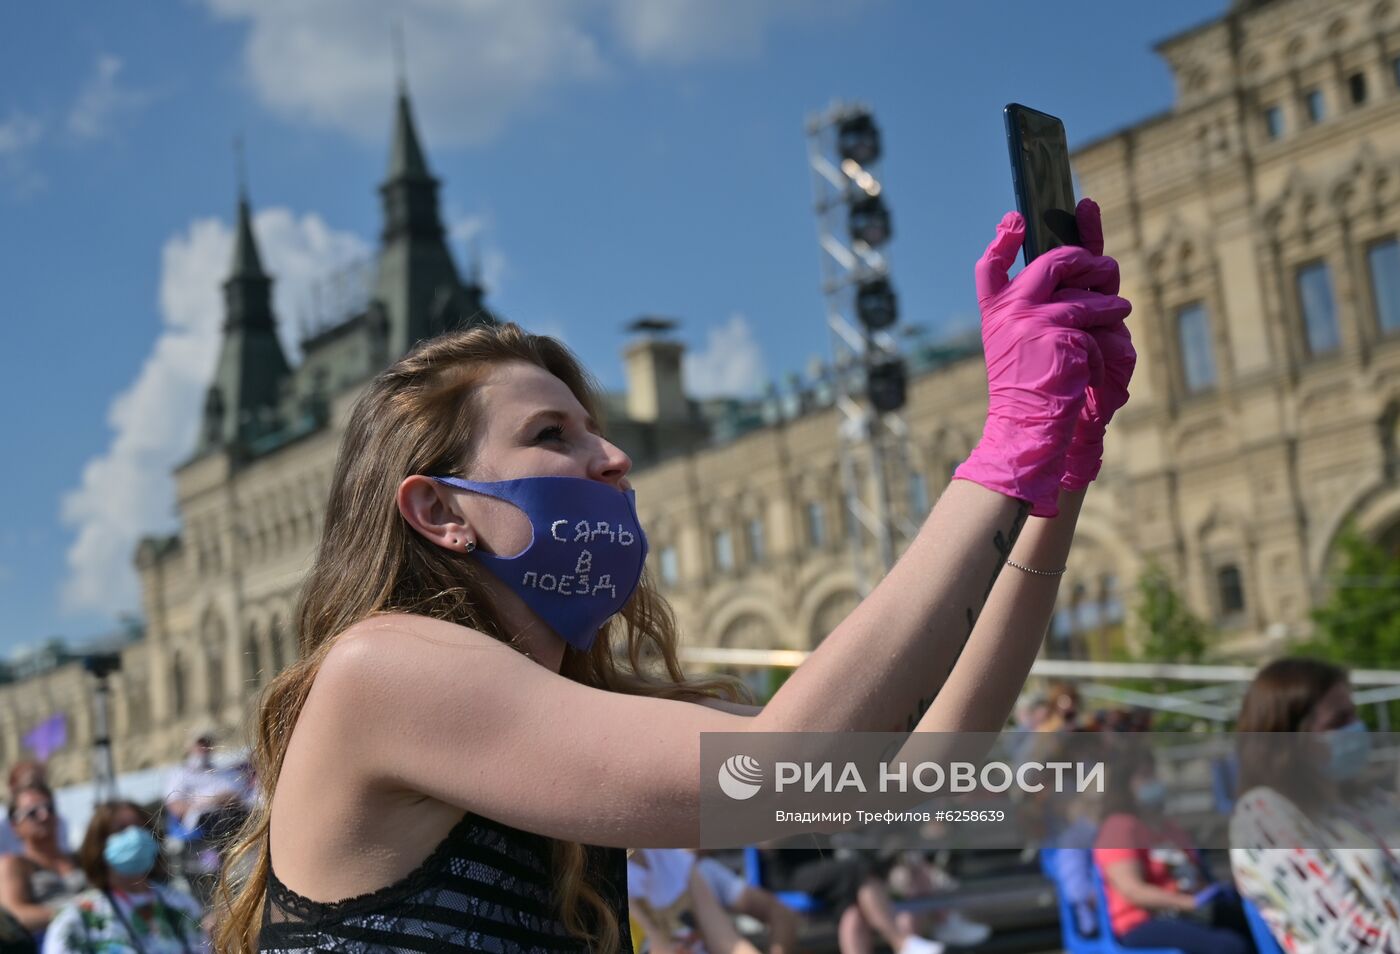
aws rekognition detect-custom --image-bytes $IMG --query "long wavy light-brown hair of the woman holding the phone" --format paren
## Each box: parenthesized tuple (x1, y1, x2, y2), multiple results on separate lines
(214, 324, 745, 954)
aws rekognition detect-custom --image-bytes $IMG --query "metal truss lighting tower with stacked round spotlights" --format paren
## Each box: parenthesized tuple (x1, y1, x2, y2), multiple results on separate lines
(806, 102, 909, 595)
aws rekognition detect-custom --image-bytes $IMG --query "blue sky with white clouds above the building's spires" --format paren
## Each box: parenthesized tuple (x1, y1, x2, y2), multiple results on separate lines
(0, 0, 1225, 653)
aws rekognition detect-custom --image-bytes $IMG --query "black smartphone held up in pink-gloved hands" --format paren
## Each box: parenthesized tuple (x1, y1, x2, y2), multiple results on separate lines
(1002, 102, 1081, 265)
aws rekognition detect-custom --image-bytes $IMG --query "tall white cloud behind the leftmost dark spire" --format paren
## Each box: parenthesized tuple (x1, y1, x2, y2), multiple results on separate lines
(60, 209, 370, 612)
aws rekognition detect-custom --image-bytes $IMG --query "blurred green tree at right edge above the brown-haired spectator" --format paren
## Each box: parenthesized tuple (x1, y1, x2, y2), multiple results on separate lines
(1302, 525, 1400, 670)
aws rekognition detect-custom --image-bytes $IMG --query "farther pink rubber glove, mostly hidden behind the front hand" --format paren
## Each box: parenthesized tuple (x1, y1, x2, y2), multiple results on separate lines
(1060, 199, 1137, 490)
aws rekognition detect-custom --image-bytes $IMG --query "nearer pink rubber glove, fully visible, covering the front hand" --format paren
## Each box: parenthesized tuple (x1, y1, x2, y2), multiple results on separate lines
(953, 212, 1131, 517)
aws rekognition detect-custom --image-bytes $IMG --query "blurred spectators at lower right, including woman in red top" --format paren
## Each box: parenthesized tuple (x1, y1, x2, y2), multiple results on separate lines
(1022, 658, 1400, 954)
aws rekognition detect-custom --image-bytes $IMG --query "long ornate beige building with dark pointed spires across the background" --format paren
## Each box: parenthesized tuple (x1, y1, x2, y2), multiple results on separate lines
(0, 0, 1400, 783)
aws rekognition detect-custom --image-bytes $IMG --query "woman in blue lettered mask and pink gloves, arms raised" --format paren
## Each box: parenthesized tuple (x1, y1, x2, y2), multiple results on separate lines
(216, 202, 1135, 954)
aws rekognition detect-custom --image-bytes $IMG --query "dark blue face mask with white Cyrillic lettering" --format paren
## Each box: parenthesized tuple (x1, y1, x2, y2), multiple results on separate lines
(433, 476, 647, 653)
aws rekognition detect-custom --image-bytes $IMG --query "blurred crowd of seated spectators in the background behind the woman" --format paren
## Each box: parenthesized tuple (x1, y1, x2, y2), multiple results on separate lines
(0, 658, 1400, 954)
